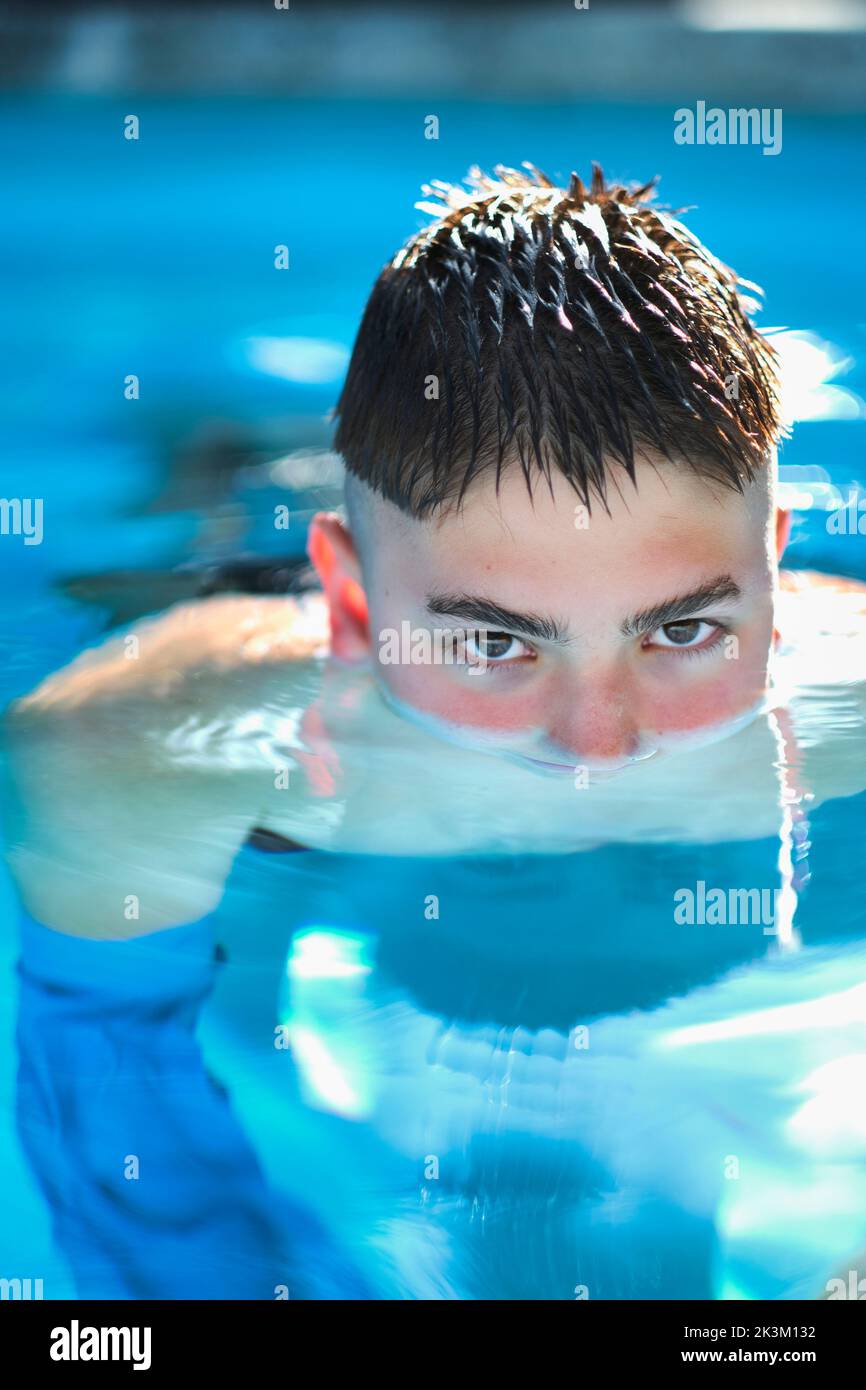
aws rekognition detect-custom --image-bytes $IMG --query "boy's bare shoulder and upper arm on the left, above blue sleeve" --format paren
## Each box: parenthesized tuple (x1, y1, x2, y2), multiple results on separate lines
(4, 598, 322, 937)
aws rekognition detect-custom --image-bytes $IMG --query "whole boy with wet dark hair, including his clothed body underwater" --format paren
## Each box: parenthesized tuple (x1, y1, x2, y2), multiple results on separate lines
(8, 159, 863, 1298)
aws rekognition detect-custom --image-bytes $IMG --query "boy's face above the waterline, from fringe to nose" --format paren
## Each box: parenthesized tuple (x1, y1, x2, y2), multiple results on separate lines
(313, 463, 781, 771)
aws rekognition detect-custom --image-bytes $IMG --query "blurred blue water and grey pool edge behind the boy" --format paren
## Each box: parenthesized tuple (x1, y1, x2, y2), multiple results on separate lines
(0, 0, 866, 698)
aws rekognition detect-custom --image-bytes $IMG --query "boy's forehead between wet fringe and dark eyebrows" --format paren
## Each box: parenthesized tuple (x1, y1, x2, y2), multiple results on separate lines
(379, 463, 771, 603)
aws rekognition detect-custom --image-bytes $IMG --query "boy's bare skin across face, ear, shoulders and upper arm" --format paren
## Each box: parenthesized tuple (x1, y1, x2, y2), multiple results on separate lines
(6, 468, 866, 937)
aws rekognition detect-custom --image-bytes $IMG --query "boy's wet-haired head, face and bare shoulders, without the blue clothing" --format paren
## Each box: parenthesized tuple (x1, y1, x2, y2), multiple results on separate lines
(1, 167, 862, 937)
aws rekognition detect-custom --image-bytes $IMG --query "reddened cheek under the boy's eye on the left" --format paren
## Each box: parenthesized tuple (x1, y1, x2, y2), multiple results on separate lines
(379, 664, 544, 734)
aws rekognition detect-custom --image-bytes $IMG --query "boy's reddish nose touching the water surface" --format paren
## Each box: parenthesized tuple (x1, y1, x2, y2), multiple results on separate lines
(546, 671, 641, 763)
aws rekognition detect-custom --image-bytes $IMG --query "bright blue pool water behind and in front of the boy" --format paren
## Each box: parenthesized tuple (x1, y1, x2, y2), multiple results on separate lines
(0, 99, 866, 1300)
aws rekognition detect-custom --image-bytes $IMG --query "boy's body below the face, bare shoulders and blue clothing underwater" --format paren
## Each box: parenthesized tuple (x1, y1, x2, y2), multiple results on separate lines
(10, 575, 866, 1298)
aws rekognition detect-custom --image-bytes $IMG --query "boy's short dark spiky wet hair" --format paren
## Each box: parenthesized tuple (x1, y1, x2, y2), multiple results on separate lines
(335, 164, 783, 517)
